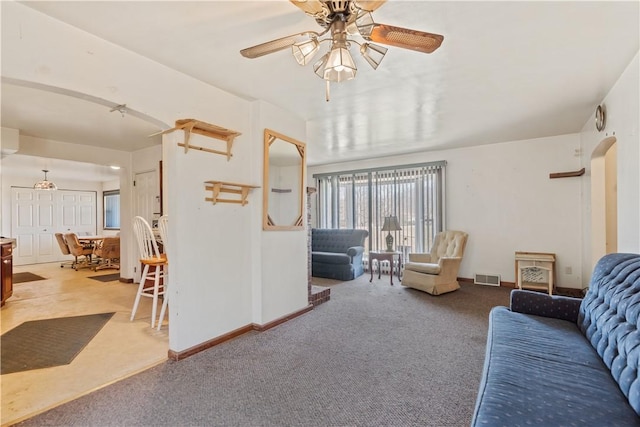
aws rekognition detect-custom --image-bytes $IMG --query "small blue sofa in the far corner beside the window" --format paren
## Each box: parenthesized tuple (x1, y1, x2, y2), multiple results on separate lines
(311, 228, 369, 280)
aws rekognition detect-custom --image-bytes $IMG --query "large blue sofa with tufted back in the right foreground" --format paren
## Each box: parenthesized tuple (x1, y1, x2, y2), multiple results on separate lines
(471, 254, 640, 426)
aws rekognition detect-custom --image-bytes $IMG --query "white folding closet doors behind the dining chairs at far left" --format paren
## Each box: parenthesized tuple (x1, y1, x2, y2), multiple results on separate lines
(11, 187, 96, 265)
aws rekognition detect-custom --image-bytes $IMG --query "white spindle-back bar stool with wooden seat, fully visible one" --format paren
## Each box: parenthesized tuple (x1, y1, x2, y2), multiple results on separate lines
(129, 216, 167, 328)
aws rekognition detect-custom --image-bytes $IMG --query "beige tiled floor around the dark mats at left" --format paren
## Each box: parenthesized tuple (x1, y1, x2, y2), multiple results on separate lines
(0, 263, 169, 426)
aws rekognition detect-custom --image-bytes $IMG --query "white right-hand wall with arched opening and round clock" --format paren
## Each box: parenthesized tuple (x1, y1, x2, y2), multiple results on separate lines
(580, 54, 640, 276)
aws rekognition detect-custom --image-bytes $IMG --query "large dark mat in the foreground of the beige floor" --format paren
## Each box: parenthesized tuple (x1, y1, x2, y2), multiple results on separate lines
(0, 313, 115, 375)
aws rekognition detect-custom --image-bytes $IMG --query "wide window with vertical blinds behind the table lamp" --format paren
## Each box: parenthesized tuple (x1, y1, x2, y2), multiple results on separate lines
(314, 162, 446, 253)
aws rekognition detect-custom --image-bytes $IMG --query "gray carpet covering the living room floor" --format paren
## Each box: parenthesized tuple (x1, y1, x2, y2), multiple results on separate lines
(20, 275, 509, 426)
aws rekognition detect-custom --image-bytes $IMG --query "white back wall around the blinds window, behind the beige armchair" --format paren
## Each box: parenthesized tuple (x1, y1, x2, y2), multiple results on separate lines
(308, 134, 582, 288)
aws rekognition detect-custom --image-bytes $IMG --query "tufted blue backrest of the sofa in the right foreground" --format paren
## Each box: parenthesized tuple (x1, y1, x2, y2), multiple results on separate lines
(578, 254, 640, 415)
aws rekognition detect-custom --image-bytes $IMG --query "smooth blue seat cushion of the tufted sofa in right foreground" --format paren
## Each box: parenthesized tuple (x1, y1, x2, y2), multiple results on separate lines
(472, 307, 639, 426)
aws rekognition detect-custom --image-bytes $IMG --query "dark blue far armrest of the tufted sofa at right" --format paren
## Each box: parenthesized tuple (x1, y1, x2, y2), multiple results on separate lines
(510, 289, 582, 323)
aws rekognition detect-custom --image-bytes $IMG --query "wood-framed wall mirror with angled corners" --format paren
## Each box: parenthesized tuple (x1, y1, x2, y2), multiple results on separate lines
(262, 129, 306, 230)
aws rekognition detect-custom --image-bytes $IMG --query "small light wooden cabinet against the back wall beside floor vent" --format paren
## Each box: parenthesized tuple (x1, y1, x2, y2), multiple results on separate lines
(516, 252, 556, 295)
